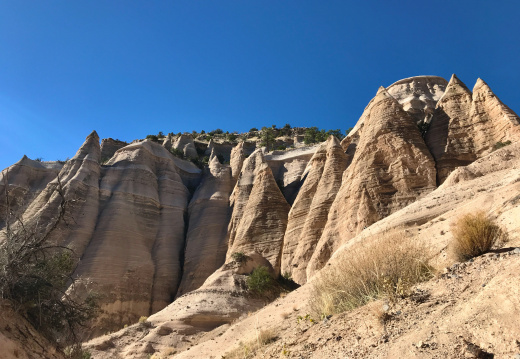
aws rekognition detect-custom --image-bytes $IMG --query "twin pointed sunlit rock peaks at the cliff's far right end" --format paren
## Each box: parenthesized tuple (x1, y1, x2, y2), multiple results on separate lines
(425, 75, 520, 184)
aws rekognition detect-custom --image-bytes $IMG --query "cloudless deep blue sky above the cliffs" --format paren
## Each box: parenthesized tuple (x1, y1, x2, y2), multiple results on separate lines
(0, 0, 520, 168)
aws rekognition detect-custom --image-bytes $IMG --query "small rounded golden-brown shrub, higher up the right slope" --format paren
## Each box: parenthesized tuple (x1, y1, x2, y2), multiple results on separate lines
(451, 212, 507, 261)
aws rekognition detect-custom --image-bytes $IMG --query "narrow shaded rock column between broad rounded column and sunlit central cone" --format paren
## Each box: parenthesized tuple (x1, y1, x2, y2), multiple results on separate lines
(176, 156, 234, 296)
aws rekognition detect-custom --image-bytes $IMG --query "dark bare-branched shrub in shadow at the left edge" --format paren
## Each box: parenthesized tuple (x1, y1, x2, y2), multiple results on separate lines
(0, 174, 97, 345)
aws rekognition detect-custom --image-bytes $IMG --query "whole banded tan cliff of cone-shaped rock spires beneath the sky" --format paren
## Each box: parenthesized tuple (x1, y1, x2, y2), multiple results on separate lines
(0, 76, 520, 357)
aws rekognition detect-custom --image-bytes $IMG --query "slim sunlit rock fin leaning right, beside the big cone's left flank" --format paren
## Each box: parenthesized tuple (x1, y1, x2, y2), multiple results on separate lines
(281, 136, 348, 284)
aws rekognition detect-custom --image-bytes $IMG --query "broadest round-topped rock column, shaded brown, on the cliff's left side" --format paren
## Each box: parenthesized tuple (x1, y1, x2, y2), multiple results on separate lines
(70, 141, 196, 331)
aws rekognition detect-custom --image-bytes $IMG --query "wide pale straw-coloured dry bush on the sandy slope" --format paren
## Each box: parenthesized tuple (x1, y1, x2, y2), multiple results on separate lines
(311, 233, 432, 317)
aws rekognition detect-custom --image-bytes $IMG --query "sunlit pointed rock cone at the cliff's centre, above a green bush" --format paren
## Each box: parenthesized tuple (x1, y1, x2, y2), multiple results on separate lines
(227, 150, 290, 273)
